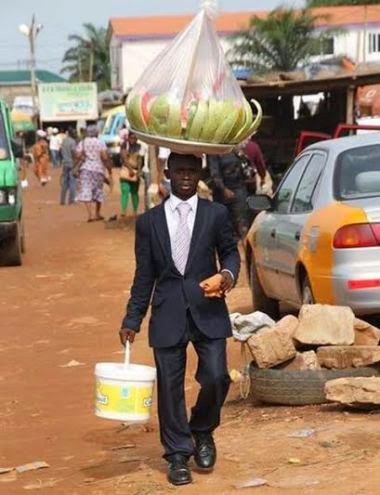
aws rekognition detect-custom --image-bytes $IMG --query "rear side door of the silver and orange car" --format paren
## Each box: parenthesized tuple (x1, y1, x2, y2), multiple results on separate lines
(276, 151, 327, 303)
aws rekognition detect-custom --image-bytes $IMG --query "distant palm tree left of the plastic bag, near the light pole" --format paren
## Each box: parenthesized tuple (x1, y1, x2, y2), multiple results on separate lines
(61, 23, 111, 90)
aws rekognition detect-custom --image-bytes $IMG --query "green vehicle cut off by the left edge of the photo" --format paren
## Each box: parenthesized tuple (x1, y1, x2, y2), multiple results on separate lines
(0, 100, 24, 265)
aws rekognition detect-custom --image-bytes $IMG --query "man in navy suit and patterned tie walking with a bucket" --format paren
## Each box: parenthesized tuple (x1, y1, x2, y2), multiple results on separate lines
(120, 153, 240, 485)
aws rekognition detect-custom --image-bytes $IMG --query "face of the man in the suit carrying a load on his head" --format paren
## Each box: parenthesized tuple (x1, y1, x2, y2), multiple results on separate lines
(166, 160, 202, 201)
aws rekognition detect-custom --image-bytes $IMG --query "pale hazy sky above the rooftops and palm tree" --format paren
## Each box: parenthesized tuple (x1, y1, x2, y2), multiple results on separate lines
(0, 0, 301, 73)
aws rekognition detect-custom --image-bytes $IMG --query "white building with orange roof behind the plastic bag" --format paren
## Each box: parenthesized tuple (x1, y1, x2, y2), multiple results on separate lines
(108, 5, 380, 91)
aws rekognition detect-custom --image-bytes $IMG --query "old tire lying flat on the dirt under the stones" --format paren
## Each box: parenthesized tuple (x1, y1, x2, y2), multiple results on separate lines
(249, 364, 379, 406)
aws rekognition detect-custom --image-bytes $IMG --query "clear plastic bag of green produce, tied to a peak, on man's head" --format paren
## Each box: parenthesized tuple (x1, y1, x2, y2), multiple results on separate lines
(127, 1, 262, 147)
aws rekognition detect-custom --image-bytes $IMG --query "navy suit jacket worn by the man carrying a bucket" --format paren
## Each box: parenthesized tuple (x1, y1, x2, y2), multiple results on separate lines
(122, 198, 240, 348)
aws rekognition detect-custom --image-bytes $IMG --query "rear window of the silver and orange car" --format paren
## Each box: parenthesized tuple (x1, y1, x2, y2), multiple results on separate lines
(335, 145, 380, 200)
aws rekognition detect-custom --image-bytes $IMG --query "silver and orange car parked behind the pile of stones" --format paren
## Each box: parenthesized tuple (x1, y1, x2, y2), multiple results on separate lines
(245, 132, 380, 315)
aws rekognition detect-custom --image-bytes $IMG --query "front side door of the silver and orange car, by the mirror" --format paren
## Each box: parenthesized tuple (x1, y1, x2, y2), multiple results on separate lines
(255, 153, 310, 299)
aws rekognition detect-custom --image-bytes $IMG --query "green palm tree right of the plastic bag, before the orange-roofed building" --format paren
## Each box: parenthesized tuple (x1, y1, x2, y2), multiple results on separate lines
(229, 7, 331, 73)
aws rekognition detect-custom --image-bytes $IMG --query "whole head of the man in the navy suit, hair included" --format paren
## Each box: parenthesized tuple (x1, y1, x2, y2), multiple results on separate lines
(166, 153, 202, 201)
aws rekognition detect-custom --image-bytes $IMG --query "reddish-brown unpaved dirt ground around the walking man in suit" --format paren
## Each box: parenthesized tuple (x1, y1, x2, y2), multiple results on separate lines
(0, 171, 380, 495)
